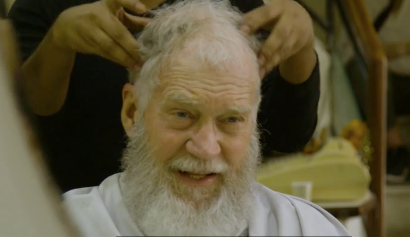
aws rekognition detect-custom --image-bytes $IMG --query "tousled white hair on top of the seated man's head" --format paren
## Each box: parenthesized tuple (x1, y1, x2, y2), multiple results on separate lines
(130, 0, 260, 111)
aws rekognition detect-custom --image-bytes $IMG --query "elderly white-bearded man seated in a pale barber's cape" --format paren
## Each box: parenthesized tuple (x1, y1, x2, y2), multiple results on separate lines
(64, 0, 349, 237)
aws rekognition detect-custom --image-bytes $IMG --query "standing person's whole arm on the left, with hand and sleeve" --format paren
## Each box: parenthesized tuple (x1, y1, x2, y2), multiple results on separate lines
(10, 0, 148, 116)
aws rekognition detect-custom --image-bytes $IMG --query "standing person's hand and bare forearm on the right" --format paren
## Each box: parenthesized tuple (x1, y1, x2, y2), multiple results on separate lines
(241, 0, 316, 84)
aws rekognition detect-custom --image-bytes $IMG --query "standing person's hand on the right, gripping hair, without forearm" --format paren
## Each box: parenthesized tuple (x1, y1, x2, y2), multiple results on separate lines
(241, 0, 314, 77)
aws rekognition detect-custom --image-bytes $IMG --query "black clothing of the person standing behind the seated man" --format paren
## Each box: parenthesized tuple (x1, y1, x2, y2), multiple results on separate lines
(9, 0, 319, 191)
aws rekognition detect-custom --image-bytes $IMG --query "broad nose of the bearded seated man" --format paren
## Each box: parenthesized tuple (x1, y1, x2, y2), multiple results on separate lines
(186, 123, 221, 159)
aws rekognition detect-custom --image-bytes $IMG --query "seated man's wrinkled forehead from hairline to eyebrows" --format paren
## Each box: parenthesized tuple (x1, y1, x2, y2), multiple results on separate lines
(151, 43, 260, 105)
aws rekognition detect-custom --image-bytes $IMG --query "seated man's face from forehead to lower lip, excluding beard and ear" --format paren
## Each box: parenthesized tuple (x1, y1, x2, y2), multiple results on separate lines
(145, 50, 259, 200)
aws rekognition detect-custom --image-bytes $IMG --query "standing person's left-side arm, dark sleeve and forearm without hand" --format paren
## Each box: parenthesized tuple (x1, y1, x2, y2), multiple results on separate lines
(8, 0, 75, 115)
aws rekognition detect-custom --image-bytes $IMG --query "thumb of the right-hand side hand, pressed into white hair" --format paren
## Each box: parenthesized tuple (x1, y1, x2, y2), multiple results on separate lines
(239, 5, 281, 34)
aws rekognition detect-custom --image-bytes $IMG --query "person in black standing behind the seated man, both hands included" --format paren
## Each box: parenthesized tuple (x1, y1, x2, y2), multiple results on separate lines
(9, 0, 320, 192)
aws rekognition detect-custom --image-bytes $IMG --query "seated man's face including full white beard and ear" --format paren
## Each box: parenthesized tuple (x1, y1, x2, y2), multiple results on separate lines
(122, 46, 260, 236)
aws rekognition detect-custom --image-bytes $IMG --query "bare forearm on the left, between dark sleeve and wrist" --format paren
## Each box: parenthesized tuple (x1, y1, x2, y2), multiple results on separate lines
(21, 34, 75, 116)
